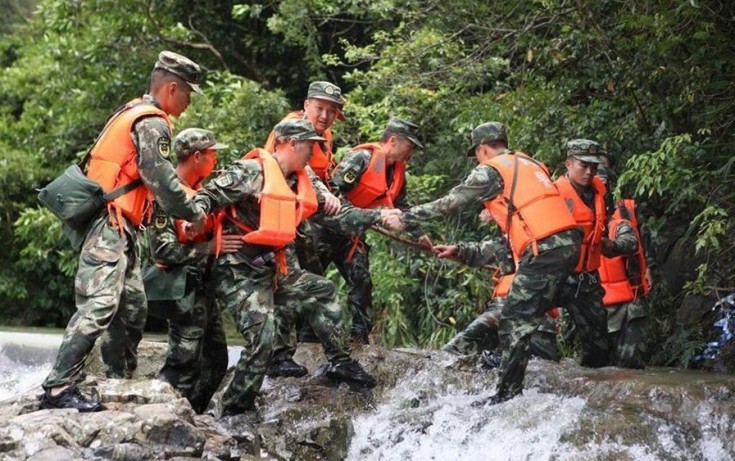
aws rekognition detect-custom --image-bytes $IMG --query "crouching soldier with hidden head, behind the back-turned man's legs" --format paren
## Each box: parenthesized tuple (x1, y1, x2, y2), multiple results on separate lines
(440, 230, 560, 362)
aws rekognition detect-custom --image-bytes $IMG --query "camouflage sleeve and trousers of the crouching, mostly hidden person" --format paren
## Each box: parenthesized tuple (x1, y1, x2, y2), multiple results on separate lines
(442, 240, 560, 361)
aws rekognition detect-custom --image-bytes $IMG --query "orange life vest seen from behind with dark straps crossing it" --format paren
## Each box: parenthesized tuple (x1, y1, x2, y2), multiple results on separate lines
(482, 152, 577, 260)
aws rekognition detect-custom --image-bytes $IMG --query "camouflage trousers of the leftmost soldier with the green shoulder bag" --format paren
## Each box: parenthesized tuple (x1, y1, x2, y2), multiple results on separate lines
(43, 213, 148, 389)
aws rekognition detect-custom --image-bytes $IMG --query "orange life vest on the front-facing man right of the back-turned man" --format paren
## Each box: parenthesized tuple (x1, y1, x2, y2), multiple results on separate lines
(555, 175, 607, 274)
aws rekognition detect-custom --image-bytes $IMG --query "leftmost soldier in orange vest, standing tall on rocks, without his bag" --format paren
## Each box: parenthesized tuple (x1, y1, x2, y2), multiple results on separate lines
(41, 51, 205, 411)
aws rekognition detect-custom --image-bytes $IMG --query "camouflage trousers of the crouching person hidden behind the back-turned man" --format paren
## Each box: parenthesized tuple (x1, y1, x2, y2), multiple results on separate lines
(442, 298, 561, 362)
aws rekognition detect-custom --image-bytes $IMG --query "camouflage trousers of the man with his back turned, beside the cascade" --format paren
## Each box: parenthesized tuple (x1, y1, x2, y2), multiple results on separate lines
(497, 245, 609, 397)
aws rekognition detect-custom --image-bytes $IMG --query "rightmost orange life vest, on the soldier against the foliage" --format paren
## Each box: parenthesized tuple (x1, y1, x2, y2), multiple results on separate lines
(600, 199, 651, 306)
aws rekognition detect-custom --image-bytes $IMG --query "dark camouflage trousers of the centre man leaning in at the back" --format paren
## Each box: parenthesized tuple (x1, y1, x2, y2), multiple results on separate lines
(318, 230, 373, 335)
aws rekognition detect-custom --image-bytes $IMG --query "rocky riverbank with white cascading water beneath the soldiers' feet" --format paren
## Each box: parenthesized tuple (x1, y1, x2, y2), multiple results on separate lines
(0, 343, 735, 461)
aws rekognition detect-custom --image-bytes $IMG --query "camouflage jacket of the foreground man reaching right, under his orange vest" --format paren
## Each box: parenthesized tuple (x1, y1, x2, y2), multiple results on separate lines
(194, 160, 380, 264)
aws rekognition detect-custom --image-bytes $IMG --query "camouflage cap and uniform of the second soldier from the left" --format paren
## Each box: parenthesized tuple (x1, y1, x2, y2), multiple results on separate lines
(146, 128, 228, 413)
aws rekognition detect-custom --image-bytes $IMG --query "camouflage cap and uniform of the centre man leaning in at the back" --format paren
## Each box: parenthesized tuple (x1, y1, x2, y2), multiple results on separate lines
(326, 119, 423, 338)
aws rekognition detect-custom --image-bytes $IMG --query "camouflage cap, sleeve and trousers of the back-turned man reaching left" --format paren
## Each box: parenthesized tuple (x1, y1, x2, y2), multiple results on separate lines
(404, 126, 609, 401)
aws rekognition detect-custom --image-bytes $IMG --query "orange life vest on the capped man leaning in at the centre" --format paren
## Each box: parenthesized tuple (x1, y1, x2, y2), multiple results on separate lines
(345, 142, 406, 208)
